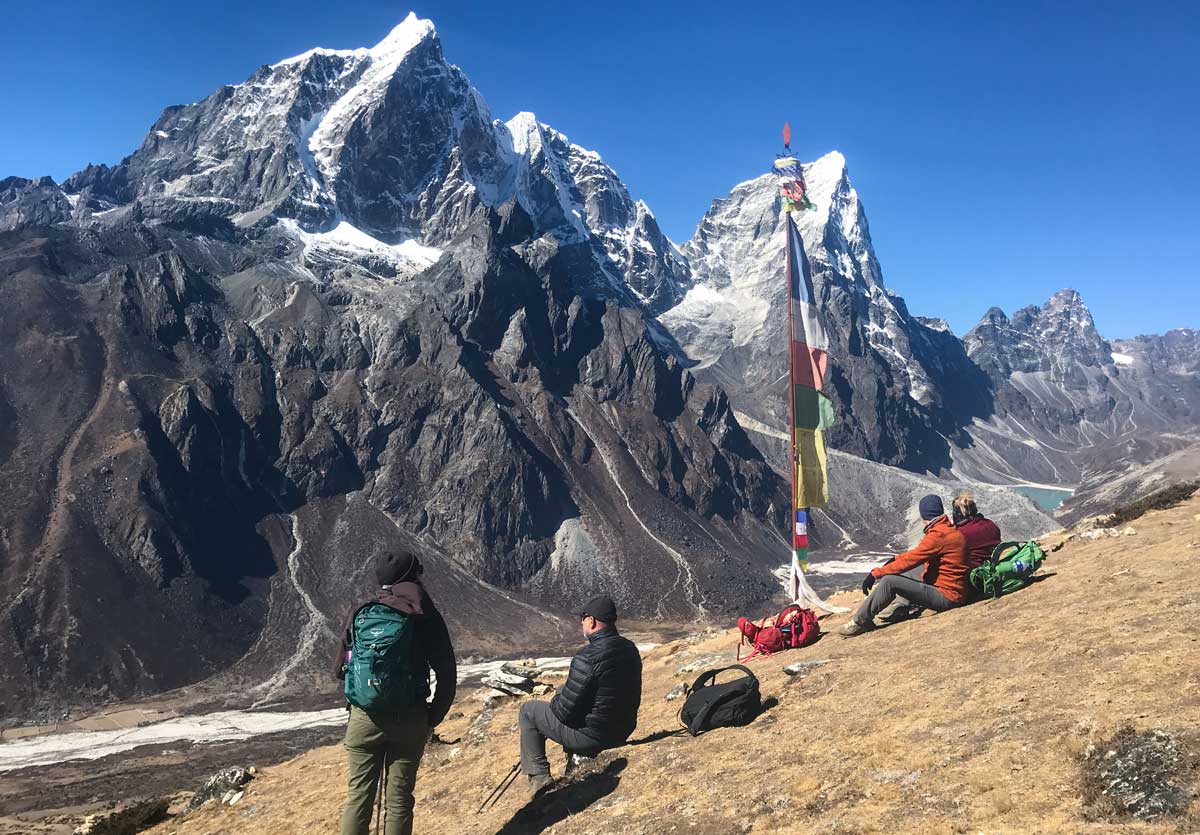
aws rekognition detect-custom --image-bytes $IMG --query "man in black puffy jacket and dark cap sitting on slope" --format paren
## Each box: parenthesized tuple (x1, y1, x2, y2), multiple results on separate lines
(520, 595, 642, 792)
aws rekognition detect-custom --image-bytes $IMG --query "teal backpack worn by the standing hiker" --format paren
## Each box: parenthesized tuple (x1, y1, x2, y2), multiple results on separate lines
(342, 602, 428, 713)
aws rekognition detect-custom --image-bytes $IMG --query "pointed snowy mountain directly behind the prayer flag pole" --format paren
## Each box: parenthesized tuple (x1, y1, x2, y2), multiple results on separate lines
(661, 154, 989, 470)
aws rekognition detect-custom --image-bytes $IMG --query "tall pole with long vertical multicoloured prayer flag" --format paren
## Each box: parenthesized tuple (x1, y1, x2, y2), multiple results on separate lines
(774, 125, 834, 583)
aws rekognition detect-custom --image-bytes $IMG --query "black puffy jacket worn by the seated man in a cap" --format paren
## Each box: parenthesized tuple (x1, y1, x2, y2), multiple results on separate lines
(550, 626, 642, 747)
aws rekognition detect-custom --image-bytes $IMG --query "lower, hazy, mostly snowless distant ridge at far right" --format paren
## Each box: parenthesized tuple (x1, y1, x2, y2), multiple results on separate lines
(955, 289, 1200, 489)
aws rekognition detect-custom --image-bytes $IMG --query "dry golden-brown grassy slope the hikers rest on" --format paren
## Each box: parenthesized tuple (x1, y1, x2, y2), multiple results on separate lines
(154, 498, 1200, 835)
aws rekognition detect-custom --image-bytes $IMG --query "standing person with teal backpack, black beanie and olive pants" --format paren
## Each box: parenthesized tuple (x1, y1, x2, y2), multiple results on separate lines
(334, 551, 457, 835)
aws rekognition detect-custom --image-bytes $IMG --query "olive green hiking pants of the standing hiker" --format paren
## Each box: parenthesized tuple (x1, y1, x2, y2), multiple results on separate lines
(342, 704, 430, 835)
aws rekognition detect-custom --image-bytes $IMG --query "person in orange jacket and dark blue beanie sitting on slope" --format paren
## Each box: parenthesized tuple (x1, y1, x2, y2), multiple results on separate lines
(839, 495, 971, 638)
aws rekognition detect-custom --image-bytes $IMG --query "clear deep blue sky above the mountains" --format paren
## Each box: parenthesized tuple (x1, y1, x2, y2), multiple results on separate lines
(0, 0, 1200, 337)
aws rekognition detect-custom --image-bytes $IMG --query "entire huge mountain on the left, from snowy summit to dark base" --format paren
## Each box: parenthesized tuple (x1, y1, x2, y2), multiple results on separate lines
(0, 17, 772, 709)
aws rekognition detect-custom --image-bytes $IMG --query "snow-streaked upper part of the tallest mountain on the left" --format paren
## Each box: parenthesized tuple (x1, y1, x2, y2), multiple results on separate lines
(49, 14, 690, 313)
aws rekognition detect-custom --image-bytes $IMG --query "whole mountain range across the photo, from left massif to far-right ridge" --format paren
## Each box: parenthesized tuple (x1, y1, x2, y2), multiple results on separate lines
(0, 16, 1200, 710)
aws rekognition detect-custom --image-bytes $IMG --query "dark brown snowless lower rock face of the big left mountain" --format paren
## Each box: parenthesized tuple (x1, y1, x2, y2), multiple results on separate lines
(0, 187, 786, 704)
